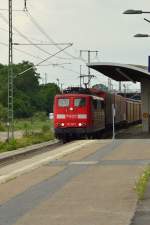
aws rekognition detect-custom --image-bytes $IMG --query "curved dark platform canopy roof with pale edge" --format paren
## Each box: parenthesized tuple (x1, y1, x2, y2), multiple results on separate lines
(87, 62, 150, 82)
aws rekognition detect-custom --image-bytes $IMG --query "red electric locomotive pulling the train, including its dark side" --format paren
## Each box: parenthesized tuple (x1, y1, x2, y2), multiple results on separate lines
(54, 88, 105, 141)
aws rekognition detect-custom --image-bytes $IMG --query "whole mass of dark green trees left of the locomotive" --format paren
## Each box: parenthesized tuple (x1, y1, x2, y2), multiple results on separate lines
(0, 61, 60, 118)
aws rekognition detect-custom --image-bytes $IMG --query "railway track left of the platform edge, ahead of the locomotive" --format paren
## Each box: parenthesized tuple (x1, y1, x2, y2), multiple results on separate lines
(0, 140, 63, 168)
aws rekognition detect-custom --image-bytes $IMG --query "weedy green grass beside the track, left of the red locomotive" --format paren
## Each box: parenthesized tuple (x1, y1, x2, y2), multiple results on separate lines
(0, 113, 54, 153)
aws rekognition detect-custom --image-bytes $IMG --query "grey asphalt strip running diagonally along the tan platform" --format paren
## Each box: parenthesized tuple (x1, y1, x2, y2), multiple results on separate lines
(0, 141, 120, 225)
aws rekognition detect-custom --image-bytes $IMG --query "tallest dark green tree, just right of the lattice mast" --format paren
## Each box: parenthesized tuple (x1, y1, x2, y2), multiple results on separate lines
(14, 61, 40, 118)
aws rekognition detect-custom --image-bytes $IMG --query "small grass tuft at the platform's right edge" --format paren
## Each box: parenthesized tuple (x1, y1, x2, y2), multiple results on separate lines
(135, 166, 150, 200)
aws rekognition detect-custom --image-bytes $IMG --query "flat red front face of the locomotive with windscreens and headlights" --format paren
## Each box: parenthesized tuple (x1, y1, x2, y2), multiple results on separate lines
(54, 94, 91, 138)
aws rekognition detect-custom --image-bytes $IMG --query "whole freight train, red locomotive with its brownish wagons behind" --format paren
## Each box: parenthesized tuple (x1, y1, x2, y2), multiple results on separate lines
(54, 88, 141, 142)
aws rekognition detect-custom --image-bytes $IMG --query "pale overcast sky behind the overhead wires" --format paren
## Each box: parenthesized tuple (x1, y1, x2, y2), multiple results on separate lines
(0, 0, 150, 89)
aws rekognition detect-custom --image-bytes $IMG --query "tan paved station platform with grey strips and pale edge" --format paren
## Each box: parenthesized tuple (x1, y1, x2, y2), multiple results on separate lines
(0, 131, 150, 225)
